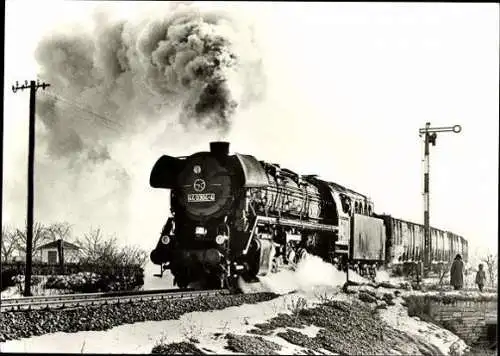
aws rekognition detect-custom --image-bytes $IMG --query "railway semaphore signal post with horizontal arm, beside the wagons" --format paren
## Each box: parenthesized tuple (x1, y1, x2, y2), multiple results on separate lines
(418, 122, 462, 276)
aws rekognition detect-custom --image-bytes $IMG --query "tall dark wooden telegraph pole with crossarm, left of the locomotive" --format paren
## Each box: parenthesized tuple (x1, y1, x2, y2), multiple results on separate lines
(12, 80, 50, 297)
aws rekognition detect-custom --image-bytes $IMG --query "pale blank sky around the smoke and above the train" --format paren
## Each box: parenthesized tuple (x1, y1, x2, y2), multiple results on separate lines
(3, 0, 499, 258)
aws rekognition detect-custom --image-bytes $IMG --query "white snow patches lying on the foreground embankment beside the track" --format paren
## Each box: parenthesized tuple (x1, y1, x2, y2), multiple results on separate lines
(0, 286, 466, 355)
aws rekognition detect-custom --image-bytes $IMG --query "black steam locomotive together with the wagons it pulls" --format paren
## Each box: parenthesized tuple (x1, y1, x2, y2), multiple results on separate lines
(150, 142, 467, 288)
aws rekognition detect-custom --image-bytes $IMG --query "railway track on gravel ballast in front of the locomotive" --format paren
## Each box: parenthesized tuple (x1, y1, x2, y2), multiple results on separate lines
(0, 289, 230, 313)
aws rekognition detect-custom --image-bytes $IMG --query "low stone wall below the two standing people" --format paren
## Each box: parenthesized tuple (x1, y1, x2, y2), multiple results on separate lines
(405, 293, 497, 345)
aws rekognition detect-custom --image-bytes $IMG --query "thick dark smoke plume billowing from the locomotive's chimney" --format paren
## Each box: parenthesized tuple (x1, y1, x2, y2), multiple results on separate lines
(36, 6, 264, 163)
